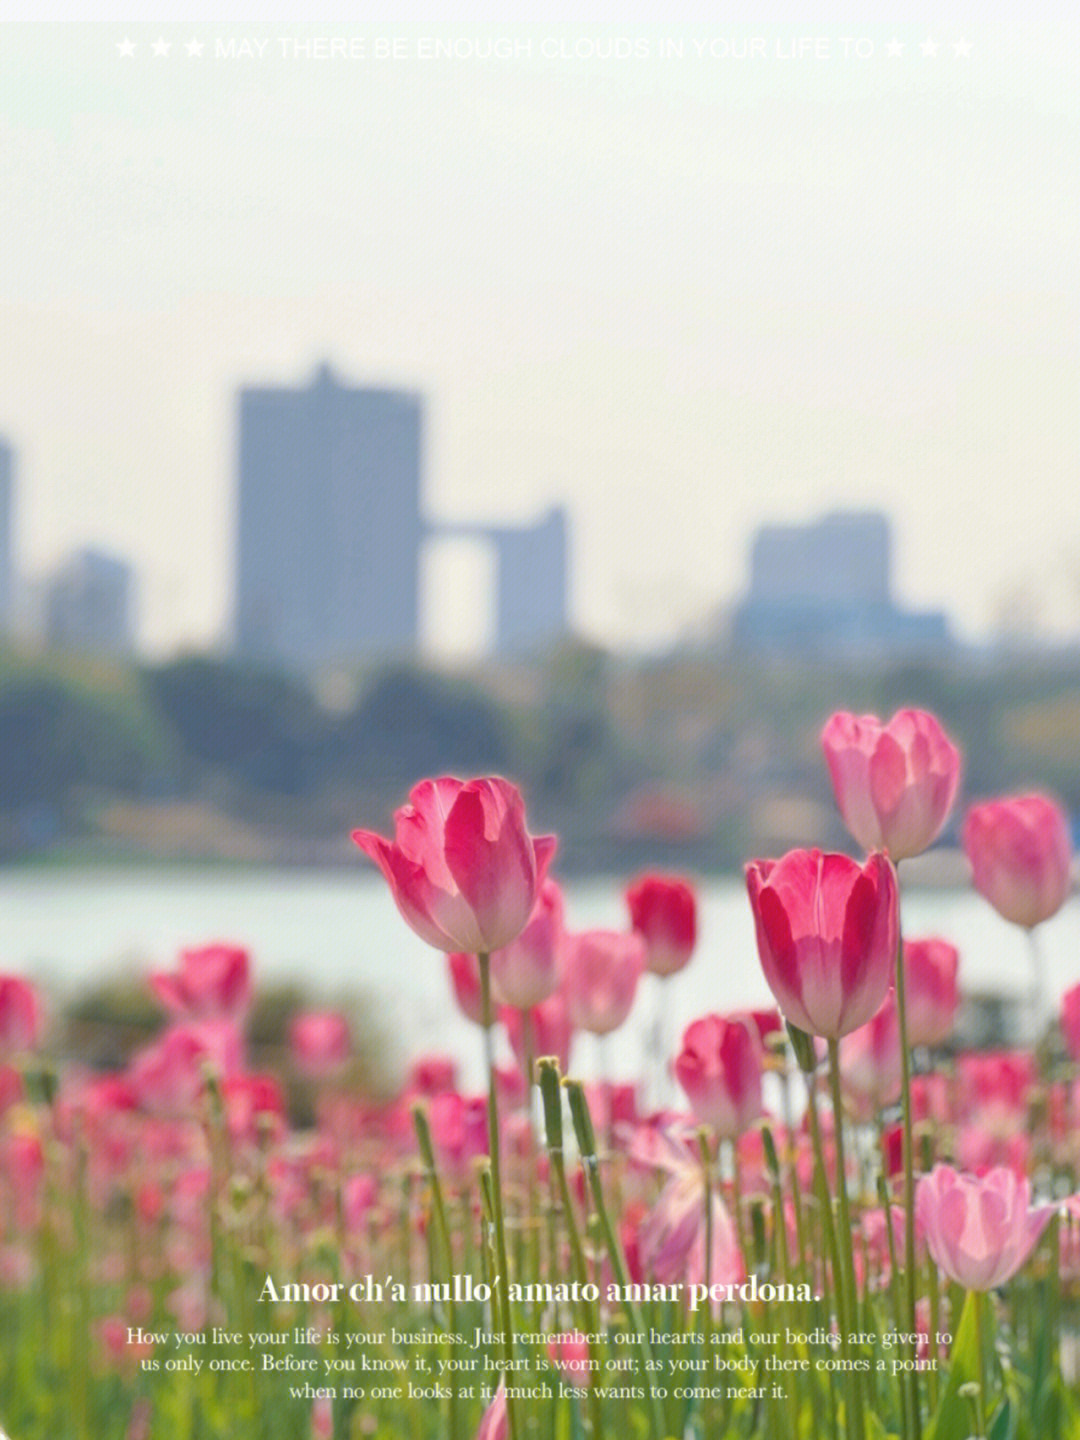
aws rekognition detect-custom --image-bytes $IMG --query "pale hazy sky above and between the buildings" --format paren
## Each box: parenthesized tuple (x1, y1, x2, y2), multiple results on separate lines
(0, 15, 1080, 652)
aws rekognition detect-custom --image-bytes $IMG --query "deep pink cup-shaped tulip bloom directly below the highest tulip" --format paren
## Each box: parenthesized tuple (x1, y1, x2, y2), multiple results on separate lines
(746, 850, 899, 1040)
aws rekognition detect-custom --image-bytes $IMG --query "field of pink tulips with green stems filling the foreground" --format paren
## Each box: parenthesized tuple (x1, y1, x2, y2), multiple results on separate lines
(0, 710, 1080, 1440)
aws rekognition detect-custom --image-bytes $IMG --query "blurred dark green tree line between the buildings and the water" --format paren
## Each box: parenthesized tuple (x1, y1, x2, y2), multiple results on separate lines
(0, 644, 1080, 868)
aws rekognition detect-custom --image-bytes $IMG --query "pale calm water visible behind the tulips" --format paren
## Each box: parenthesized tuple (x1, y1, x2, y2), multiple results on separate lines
(0, 870, 1080, 1079)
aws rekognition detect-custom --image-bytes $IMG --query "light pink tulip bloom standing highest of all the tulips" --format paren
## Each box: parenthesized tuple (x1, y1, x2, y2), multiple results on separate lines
(821, 710, 960, 861)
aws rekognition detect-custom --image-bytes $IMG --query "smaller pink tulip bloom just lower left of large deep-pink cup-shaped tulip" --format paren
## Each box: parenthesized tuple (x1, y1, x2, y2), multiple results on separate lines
(674, 1015, 765, 1140)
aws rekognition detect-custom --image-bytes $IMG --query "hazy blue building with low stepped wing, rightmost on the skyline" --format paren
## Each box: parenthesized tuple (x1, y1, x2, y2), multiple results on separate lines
(733, 511, 949, 654)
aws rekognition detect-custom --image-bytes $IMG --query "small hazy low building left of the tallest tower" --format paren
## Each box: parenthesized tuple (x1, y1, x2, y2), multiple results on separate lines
(43, 550, 134, 655)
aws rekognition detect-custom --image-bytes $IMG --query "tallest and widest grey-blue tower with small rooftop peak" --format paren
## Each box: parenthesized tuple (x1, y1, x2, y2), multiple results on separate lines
(236, 366, 423, 667)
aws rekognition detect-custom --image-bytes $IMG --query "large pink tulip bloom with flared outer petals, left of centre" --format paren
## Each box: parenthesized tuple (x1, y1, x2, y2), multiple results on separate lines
(353, 775, 556, 955)
